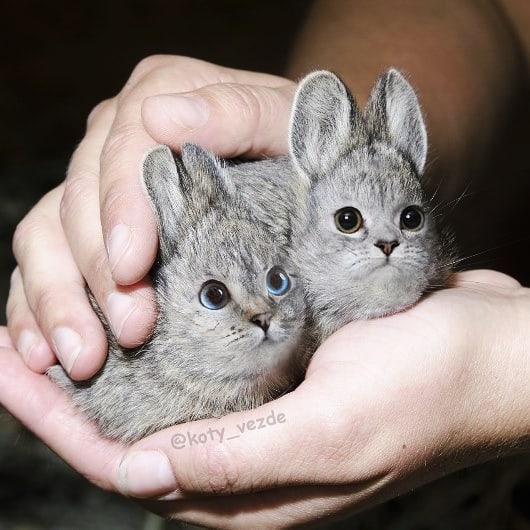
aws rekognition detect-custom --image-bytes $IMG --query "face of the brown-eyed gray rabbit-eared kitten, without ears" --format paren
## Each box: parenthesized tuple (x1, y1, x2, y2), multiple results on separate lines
(300, 146, 439, 329)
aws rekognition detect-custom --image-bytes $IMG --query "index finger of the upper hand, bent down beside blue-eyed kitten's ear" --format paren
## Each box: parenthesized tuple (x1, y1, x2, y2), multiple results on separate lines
(96, 56, 285, 285)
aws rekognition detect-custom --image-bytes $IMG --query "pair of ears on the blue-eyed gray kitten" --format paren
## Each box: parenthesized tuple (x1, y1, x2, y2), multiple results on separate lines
(142, 144, 223, 261)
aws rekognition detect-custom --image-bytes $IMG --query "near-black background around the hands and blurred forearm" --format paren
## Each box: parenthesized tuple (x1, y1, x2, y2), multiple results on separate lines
(0, 0, 530, 530)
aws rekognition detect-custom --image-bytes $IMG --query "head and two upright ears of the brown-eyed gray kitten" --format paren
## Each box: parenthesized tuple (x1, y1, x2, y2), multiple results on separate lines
(289, 69, 453, 338)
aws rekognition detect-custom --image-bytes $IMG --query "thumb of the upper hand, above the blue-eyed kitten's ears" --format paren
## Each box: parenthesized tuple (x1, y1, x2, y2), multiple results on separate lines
(142, 81, 296, 157)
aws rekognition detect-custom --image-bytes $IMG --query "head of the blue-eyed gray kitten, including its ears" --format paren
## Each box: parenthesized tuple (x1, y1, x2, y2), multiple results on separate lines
(143, 145, 305, 386)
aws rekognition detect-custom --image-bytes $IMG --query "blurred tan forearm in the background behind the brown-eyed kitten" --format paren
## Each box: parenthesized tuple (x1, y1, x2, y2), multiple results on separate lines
(289, 0, 526, 194)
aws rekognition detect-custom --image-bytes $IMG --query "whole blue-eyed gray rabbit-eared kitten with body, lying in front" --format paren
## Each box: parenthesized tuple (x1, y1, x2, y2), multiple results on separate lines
(48, 145, 308, 442)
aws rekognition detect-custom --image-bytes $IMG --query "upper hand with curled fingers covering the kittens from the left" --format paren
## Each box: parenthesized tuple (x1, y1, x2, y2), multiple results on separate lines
(7, 56, 294, 379)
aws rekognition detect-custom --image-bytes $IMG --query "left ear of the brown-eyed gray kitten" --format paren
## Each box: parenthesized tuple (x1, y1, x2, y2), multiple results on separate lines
(289, 70, 367, 177)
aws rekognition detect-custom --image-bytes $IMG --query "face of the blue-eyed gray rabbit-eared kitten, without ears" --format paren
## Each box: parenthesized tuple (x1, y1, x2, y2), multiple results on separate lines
(153, 212, 304, 381)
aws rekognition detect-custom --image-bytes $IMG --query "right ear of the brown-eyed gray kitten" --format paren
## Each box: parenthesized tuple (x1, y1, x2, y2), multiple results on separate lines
(365, 68, 427, 175)
